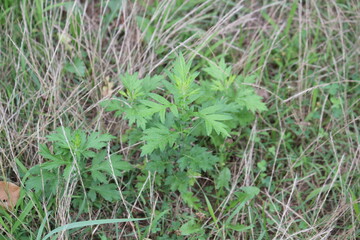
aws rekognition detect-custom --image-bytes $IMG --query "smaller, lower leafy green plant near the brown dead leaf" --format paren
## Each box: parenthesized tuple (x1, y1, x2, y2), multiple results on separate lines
(26, 127, 133, 205)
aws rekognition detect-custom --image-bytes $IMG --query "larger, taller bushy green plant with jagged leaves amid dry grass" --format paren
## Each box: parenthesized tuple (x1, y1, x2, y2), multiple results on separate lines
(102, 55, 266, 204)
